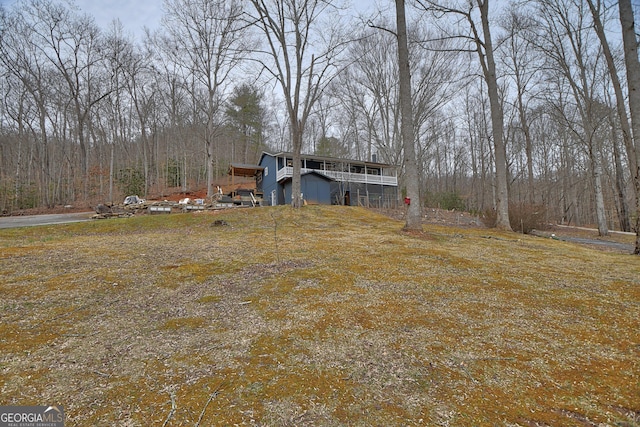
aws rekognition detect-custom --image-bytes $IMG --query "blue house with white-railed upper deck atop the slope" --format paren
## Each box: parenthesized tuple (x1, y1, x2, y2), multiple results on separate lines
(256, 152, 398, 208)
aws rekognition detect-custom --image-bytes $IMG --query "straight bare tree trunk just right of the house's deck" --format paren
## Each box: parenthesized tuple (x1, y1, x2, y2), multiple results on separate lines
(396, 0, 422, 230)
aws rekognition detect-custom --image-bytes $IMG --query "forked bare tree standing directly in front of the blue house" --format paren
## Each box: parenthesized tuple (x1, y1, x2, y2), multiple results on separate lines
(248, 0, 345, 208)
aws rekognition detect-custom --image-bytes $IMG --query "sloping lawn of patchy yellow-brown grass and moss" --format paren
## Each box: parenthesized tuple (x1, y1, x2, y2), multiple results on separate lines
(0, 206, 640, 426)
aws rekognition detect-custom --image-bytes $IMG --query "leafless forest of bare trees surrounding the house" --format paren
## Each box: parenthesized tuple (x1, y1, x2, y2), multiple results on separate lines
(0, 0, 640, 234)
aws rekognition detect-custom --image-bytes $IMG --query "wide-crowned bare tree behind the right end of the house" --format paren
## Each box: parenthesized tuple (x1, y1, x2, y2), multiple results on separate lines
(334, 14, 460, 213)
